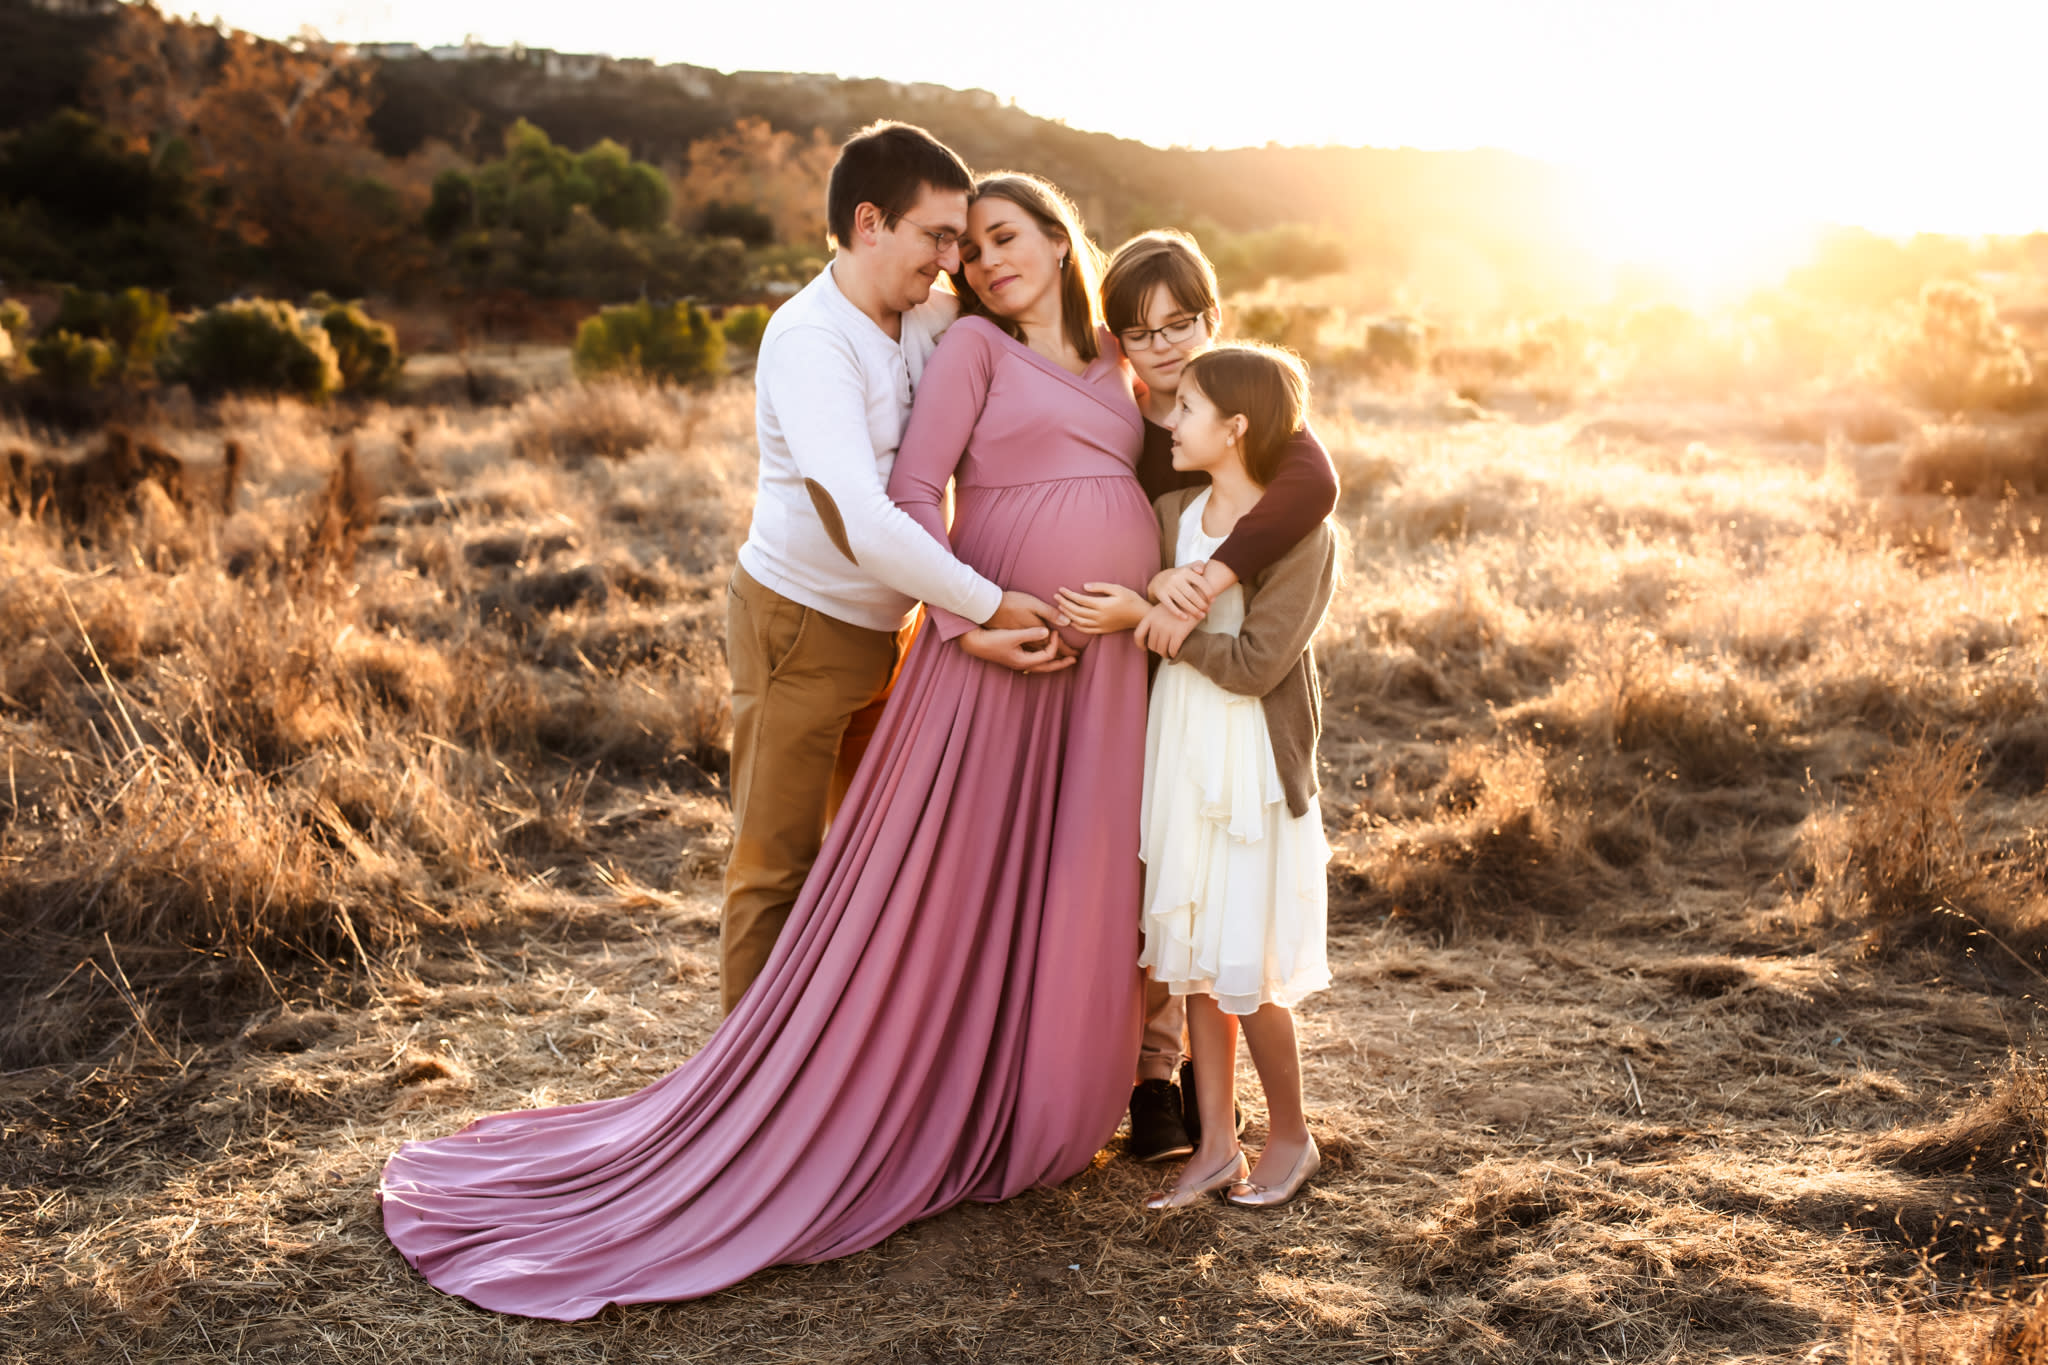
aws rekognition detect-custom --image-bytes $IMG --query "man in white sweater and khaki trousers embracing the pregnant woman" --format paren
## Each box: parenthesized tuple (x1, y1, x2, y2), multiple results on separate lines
(719, 123, 1073, 1013)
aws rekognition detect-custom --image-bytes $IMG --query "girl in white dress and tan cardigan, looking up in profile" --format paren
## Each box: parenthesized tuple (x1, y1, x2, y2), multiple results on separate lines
(1061, 344, 1337, 1209)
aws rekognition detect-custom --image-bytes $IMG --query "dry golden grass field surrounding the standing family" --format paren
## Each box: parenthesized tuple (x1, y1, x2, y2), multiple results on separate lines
(0, 366, 2048, 1365)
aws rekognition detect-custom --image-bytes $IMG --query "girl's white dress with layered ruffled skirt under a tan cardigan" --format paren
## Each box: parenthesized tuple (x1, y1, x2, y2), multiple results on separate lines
(1139, 489, 1329, 1015)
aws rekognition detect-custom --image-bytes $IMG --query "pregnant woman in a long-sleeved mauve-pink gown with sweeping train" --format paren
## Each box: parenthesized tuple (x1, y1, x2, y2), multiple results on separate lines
(381, 176, 1159, 1320)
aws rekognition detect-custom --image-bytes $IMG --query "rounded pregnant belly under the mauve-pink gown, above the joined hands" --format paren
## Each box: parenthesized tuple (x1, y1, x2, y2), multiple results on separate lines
(952, 479, 1159, 649)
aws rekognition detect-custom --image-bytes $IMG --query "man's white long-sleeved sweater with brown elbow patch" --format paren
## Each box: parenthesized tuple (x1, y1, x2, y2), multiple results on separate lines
(739, 266, 1001, 630)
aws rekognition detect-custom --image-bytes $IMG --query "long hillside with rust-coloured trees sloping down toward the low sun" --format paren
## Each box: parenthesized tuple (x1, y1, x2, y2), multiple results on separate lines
(0, 0, 1571, 307)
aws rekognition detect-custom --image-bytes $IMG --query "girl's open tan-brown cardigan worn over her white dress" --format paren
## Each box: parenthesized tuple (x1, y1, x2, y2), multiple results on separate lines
(1153, 487, 1337, 819)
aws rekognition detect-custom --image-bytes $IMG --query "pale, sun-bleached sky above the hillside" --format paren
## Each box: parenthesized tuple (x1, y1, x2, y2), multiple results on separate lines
(188, 0, 2048, 266)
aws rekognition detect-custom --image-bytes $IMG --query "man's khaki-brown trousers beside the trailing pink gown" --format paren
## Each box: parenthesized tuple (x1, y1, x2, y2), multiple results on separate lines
(719, 567, 918, 1013)
